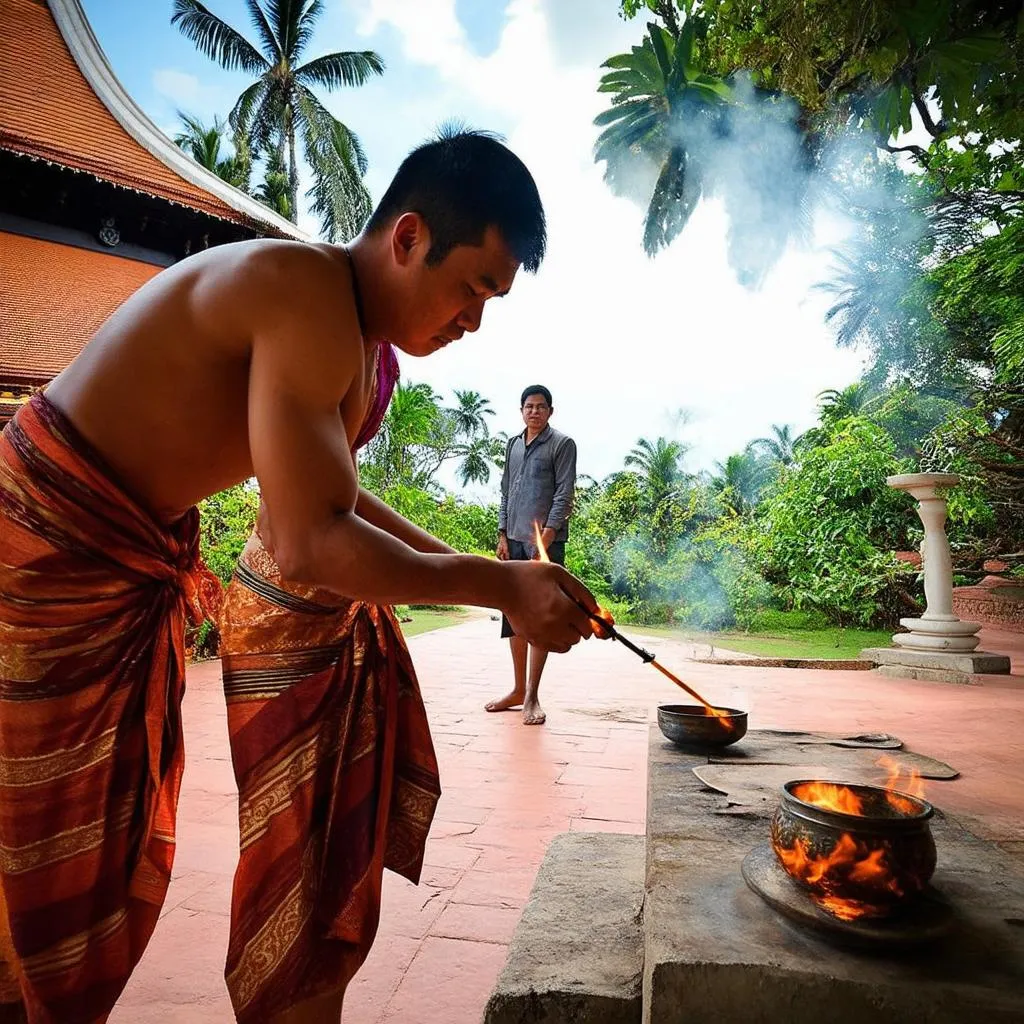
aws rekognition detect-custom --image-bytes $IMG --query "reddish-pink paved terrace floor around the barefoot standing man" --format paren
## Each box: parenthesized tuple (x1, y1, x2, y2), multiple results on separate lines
(111, 618, 1024, 1024)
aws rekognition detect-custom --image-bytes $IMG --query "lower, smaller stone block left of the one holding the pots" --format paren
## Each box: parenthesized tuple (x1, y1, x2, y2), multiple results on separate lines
(483, 833, 644, 1024)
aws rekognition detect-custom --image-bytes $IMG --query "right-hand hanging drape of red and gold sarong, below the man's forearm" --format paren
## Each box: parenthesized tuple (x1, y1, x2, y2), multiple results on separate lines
(221, 535, 440, 1024)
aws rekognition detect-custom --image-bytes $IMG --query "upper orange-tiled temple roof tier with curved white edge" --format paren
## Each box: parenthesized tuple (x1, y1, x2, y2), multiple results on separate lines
(0, 0, 306, 239)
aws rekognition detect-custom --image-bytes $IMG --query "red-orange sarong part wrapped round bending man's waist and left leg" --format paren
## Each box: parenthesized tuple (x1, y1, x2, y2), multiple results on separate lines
(0, 395, 218, 1024)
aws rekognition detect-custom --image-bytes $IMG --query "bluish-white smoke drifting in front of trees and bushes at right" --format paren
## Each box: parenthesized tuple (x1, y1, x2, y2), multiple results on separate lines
(589, 59, 931, 629)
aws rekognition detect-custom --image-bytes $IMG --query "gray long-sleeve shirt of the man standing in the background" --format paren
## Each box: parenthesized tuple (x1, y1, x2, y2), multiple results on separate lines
(498, 427, 575, 544)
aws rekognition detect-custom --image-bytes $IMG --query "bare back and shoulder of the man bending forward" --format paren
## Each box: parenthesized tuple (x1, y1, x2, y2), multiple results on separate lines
(47, 241, 373, 520)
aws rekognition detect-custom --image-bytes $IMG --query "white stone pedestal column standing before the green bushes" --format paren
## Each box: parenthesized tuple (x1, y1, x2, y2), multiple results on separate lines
(886, 473, 981, 652)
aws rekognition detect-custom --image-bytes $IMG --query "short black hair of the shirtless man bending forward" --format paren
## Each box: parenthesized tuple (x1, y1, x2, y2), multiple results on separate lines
(367, 126, 548, 272)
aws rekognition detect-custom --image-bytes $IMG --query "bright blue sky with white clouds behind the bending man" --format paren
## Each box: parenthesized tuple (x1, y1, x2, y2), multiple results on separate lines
(77, 0, 860, 495)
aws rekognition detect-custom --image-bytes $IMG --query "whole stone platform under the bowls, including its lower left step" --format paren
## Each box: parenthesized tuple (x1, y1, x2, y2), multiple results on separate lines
(484, 726, 1024, 1024)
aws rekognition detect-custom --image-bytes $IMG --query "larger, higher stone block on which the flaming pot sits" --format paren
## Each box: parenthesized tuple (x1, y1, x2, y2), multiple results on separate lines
(643, 727, 1024, 1024)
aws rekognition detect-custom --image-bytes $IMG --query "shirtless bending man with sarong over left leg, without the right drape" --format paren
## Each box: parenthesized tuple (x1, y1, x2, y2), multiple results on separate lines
(0, 133, 596, 1024)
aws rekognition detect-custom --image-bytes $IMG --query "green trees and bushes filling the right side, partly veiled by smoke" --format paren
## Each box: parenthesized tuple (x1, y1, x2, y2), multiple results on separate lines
(595, 0, 1024, 624)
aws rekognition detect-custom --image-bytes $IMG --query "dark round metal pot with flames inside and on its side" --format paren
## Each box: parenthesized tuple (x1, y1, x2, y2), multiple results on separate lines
(771, 780, 935, 921)
